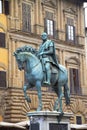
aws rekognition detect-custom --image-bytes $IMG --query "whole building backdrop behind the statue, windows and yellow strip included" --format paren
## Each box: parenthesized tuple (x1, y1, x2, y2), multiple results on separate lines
(0, 0, 87, 124)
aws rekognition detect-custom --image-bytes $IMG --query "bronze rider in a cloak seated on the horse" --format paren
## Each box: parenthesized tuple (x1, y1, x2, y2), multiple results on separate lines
(38, 32, 58, 85)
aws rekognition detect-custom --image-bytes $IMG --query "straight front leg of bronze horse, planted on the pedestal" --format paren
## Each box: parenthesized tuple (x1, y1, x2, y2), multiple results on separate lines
(36, 81, 42, 111)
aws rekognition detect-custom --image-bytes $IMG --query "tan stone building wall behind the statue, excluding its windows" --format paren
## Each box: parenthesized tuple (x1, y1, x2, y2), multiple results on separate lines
(0, 0, 87, 123)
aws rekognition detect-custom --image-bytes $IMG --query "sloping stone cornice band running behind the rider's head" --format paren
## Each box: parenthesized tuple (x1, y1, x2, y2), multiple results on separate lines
(10, 33, 85, 55)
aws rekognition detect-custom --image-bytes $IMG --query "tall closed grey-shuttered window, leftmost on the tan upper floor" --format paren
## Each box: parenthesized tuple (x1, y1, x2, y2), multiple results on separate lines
(22, 3, 31, 32)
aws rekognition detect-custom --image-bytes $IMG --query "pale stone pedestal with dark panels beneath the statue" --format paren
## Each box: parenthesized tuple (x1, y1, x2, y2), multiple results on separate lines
(27, 111, 72, 130)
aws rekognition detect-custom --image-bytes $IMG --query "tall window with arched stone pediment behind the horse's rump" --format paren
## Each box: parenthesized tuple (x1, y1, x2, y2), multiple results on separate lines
(66, 57, 82, 95)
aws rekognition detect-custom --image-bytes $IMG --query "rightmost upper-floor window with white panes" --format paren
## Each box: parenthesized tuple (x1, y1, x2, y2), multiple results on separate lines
(66, 18, 75, 42)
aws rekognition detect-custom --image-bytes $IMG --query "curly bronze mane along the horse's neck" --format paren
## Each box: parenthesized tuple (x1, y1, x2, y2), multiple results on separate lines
(15, 45, 37, 56)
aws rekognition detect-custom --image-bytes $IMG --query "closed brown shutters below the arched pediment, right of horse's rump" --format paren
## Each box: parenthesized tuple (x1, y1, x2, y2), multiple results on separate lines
(69, 68, 81, 94)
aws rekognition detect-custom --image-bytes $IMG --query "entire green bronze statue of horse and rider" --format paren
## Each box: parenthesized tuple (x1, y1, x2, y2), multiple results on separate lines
(14, 32, 70, 112)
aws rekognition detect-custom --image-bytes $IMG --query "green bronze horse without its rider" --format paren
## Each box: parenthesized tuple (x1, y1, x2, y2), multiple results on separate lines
(14, 46, 70, 112)
